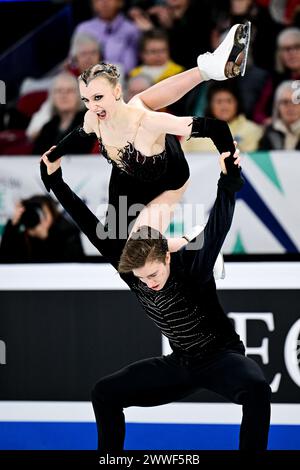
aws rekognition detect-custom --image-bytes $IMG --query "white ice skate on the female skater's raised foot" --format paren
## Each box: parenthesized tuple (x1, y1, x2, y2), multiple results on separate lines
(197, 21, 251, 80)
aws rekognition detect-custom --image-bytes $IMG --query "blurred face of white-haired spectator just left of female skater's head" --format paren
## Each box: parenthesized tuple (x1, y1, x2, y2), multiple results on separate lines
(53, 78, 79, 113)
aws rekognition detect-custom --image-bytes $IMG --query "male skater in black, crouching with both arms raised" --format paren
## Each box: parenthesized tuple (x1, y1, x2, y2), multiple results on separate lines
(42, 152, 271, 452)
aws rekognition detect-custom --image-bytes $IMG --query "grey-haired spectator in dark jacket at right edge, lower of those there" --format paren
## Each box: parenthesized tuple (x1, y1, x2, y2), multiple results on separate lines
(259, 80, 300, 150)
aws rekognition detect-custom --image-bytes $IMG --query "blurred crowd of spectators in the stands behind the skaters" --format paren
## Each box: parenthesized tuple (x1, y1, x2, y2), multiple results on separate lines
(0, 0, 300, 259)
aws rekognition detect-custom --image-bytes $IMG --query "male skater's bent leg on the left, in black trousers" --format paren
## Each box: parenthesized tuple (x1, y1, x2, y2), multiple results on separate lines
(92, 357, 195, 452)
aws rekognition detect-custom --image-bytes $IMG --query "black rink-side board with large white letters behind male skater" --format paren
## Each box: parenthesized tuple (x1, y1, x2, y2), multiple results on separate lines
(0, 290, 300, 403)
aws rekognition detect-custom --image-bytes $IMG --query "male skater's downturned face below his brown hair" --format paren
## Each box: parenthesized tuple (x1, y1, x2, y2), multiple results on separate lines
(133, 252, 171, 291)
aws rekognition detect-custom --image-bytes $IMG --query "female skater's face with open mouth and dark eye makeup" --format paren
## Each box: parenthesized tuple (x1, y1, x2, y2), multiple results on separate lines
(79, 77, 121, 121)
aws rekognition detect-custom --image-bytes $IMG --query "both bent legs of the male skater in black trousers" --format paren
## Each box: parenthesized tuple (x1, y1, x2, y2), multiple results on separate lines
(92, 350, 270, 452)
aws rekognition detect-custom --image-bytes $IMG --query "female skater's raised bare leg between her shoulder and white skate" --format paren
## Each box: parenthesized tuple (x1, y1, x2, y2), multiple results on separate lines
(130, 67, 203, 111)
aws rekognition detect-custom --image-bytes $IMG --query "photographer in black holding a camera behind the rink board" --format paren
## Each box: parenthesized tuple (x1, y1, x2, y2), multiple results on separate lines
(0, 195, 84, 263)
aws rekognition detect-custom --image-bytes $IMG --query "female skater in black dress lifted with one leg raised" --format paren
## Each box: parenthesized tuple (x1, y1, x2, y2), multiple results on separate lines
(41, 23, 250, 251)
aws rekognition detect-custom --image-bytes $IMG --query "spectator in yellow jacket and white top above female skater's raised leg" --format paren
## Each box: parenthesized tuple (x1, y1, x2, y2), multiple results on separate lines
(130, 29, 184, 83)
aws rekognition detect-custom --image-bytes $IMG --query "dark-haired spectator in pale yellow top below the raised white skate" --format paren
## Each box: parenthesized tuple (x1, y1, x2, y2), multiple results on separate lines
(182, 82, 263, 152)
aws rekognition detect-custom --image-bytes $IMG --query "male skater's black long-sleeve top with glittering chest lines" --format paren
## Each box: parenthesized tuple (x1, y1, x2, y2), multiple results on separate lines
(49, 165, 242, 360)
